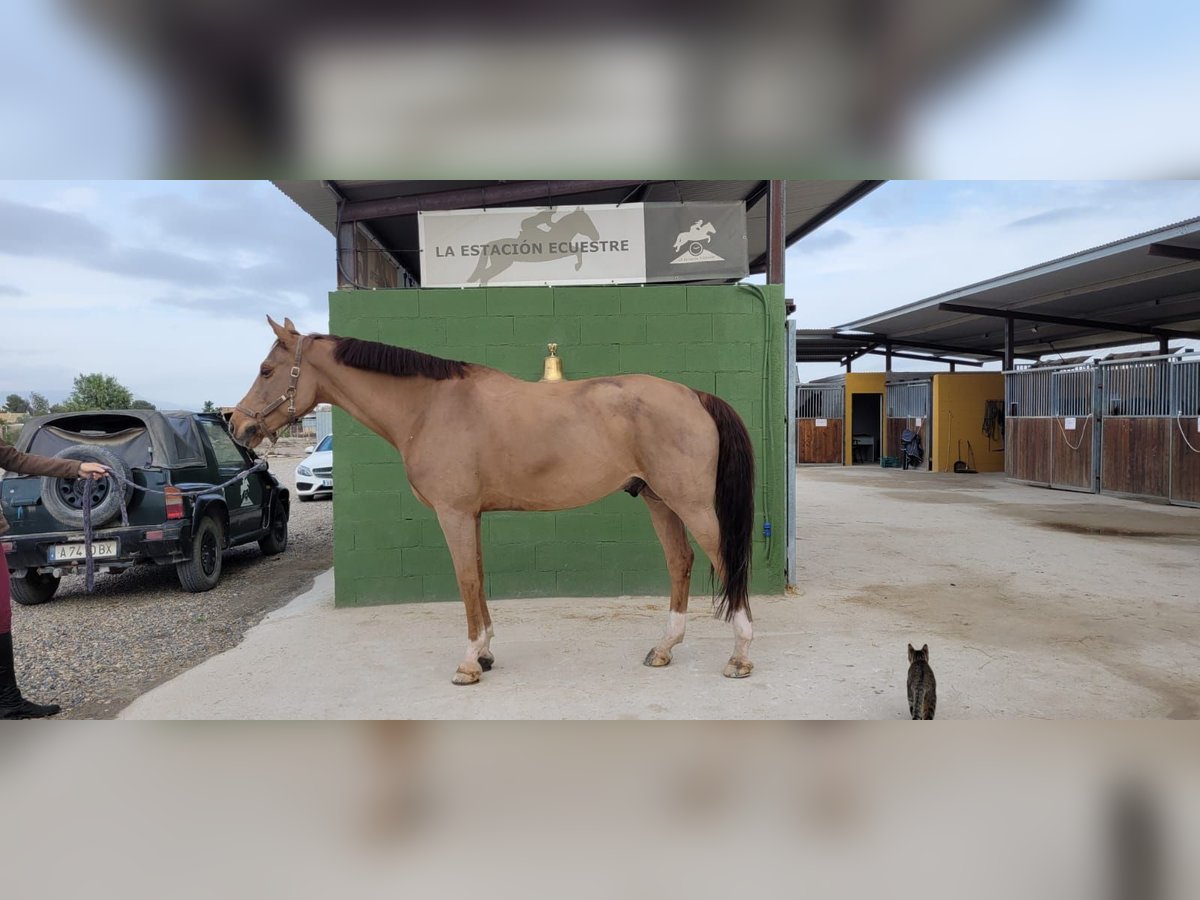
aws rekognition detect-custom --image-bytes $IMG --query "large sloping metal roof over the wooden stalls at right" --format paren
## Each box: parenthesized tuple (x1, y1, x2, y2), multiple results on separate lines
(838, 217, 1200, 358)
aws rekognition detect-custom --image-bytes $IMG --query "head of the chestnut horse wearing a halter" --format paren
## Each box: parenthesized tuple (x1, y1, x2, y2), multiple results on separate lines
(229, 316, 317, 448)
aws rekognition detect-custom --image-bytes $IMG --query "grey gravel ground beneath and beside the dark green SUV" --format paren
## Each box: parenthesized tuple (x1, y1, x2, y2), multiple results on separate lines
(5, 440, 334, 719)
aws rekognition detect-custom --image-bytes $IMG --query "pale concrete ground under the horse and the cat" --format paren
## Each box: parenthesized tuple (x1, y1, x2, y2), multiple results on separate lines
(120, 467, 1200, 719)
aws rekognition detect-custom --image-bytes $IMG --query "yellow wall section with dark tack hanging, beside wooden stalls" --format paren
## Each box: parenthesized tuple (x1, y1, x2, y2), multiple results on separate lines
(932, 372, 1004, 472)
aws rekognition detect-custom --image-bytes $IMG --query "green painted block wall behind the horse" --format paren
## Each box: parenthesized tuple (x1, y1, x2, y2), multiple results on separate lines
(329, 286, 788, 606)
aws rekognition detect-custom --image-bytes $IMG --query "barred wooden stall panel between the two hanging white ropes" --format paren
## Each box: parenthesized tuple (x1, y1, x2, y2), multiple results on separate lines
(1098, 356, 1174, 499)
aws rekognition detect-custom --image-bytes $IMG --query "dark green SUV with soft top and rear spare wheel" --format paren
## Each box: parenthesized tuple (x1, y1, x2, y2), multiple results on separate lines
(0, 409, 289, 605)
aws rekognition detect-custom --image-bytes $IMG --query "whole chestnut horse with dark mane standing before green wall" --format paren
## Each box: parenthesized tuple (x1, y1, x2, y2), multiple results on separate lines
(229, 317, 754, 684)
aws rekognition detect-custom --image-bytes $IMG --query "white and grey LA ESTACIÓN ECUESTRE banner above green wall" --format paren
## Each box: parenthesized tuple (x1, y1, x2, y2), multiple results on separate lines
(418, 203, 749, 288)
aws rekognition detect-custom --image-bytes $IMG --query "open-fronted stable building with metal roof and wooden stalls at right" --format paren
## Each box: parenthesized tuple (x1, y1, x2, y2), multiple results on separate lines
(797, 217, 1200, 505)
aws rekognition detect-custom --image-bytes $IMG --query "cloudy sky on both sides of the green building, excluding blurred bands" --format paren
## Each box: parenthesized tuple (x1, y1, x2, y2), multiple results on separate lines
(0, 181, 1200, 408)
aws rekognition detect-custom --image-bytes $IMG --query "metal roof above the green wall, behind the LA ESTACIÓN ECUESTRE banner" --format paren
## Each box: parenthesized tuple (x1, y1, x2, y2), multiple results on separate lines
(275, 180, 883, 281)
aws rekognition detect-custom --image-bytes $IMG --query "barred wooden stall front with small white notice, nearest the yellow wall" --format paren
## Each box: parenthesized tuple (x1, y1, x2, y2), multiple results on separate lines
(1004, 364, 1100, 493)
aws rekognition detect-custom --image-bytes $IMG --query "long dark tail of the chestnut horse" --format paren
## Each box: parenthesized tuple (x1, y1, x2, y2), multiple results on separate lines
(697, 391, 754, 622)
